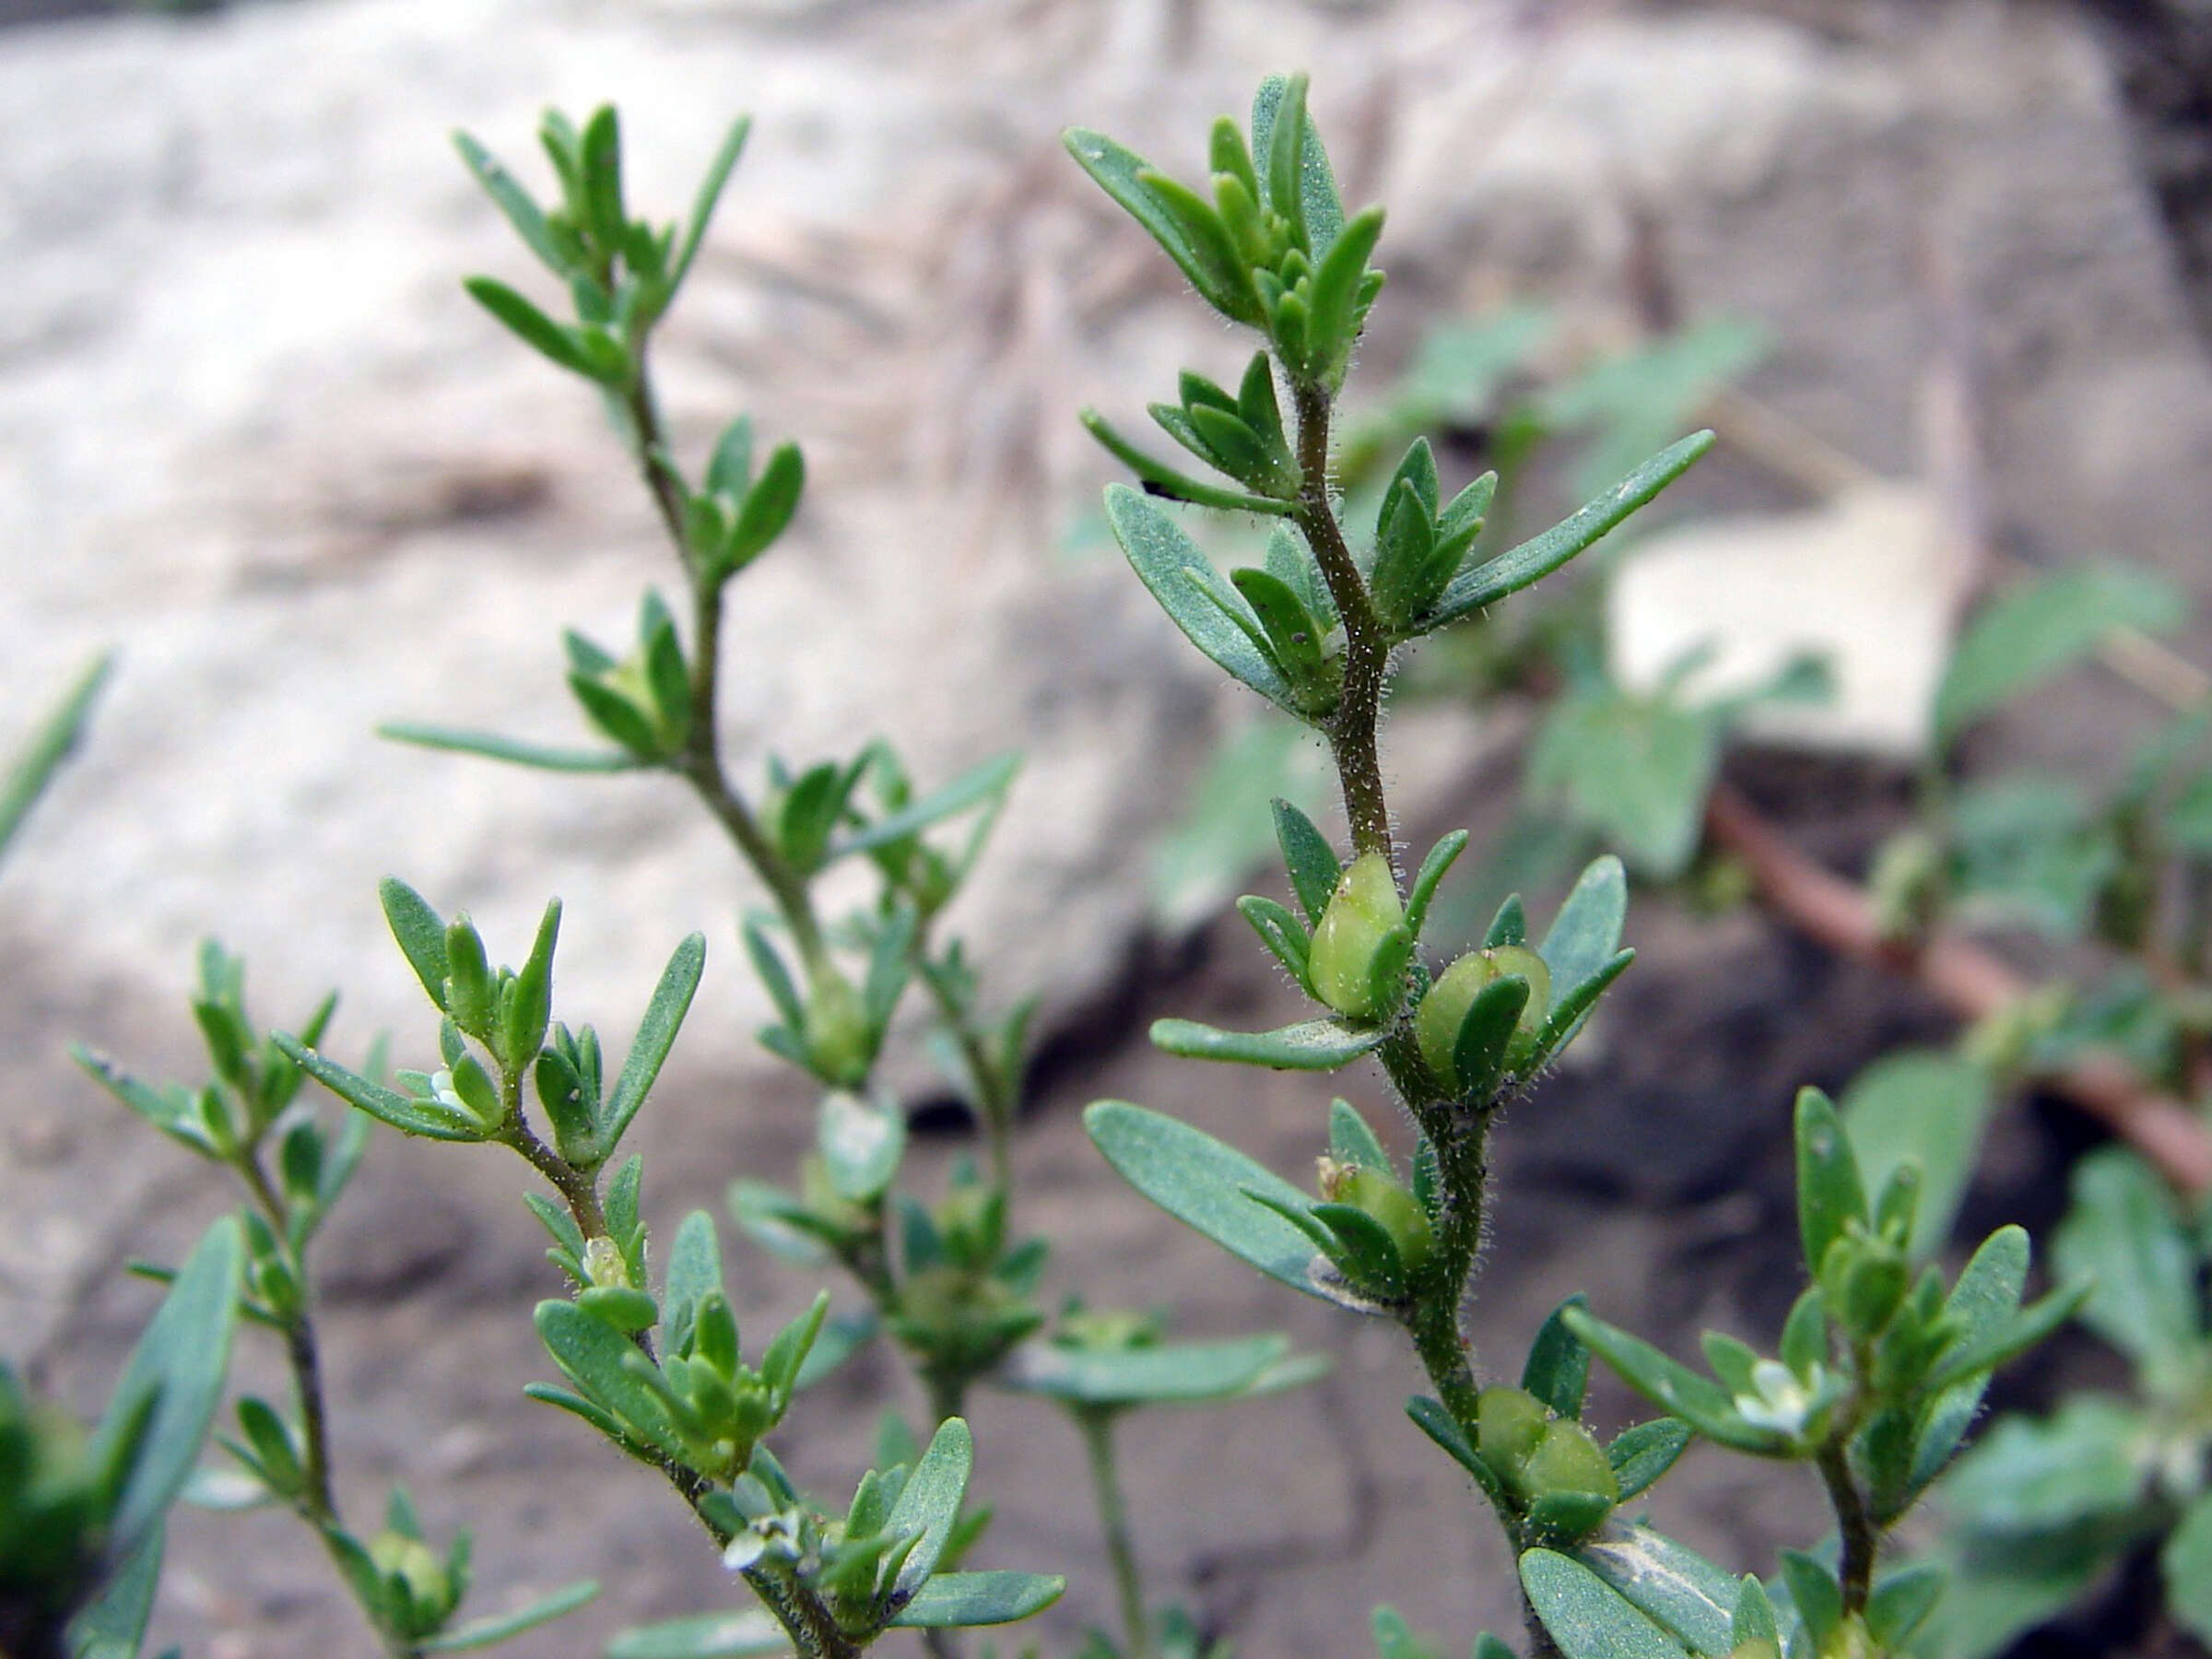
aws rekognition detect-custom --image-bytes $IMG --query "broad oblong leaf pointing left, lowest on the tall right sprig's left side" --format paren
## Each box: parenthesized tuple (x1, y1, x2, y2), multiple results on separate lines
(1084, 1100, 1321, 1296)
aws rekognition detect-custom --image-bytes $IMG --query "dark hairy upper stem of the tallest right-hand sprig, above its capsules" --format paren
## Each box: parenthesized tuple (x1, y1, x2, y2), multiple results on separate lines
(1292, 378, 1392, 858)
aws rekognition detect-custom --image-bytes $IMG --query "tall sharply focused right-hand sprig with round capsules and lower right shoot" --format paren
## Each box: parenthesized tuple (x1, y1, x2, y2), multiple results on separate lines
(1068, 79, 2081, 1659)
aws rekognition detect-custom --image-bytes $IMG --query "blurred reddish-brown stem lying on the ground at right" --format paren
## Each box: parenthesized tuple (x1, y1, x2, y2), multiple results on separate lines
(1705, 785, 2212, 1194)
